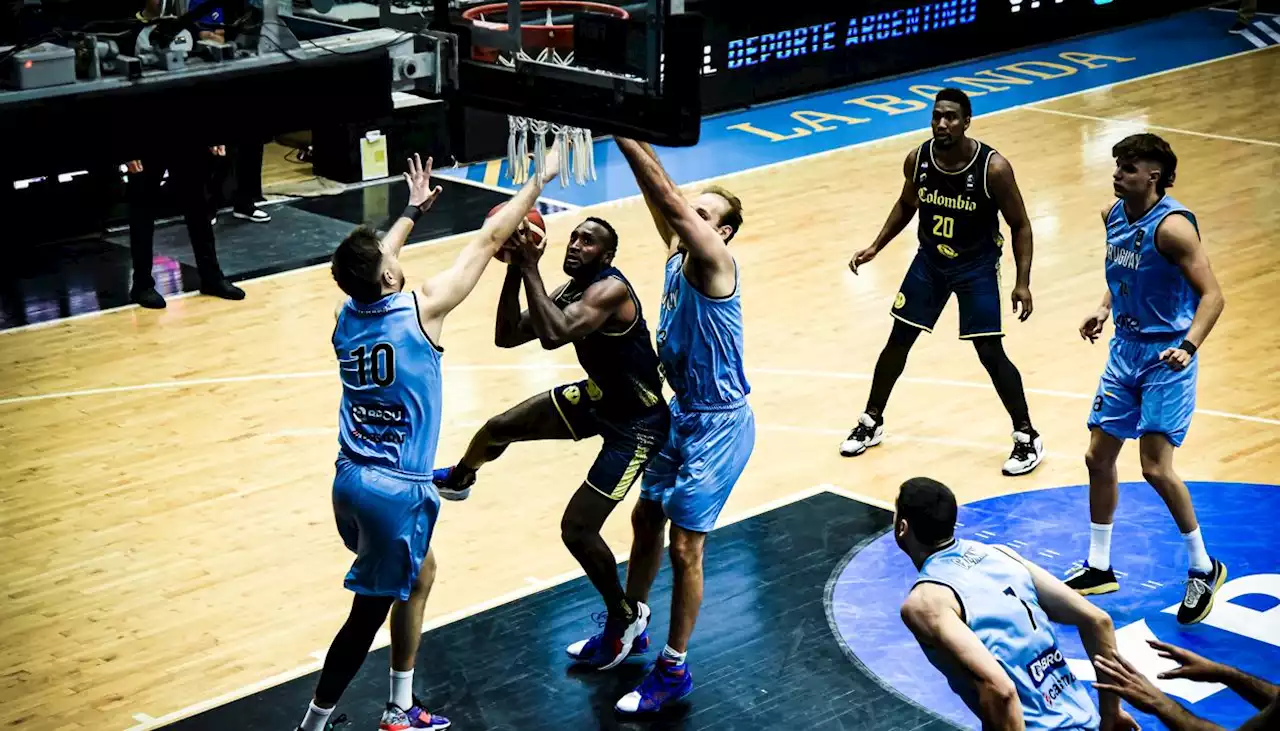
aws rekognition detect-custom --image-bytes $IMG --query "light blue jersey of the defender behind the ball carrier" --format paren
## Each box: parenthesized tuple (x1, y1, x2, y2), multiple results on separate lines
(658, 252, 751, 411)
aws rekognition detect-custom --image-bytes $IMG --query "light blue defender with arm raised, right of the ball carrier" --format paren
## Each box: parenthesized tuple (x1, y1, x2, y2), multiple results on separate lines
(601, 138, 755, 713)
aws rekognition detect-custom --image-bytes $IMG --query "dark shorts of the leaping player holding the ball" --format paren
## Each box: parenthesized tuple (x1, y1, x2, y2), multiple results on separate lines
(552, 379, 671, 501)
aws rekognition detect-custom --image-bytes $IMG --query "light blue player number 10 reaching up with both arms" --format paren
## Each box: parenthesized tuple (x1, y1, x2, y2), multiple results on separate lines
(298, 155, 559, 731)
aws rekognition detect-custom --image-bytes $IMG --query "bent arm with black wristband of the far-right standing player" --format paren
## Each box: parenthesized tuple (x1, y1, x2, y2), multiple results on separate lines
(1156, 214, 1226, 370)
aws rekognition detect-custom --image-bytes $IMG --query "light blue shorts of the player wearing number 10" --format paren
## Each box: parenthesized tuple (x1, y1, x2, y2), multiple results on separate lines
(333, 454, 440, 599)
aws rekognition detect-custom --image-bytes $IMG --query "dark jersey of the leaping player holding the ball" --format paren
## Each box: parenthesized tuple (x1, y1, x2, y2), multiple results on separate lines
(554, 266, 662, 416)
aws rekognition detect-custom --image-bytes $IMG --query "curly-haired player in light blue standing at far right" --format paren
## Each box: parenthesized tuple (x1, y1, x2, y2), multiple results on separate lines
(1066, 134, 1226, 625)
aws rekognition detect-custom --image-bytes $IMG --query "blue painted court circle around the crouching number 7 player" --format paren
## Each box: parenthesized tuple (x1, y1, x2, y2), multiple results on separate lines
(827, 483, 1280, 730)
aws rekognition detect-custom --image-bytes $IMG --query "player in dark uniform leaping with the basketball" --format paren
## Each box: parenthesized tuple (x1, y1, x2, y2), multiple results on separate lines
(435, 209, 669, 670)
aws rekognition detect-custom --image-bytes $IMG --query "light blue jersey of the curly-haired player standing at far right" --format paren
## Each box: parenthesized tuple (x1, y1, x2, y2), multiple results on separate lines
(1106, 196, 1199, 341)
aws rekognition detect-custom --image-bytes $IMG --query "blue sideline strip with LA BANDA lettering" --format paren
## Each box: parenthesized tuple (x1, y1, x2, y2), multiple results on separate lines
(439, 10, 1254, 205)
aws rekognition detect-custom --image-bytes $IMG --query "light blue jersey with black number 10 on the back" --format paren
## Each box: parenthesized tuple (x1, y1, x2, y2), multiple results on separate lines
(333, 292, 443, 476)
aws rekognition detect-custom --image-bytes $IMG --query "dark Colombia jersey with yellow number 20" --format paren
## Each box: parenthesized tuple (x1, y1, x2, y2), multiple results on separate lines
(915, 140, 1004, 268)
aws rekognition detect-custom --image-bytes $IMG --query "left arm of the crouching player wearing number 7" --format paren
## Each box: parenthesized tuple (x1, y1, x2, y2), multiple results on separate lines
(901, 584, 1025, 731)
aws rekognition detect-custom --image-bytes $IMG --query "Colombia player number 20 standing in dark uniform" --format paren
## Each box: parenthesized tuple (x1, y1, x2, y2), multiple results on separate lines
(840, 88, 1044, 475)
